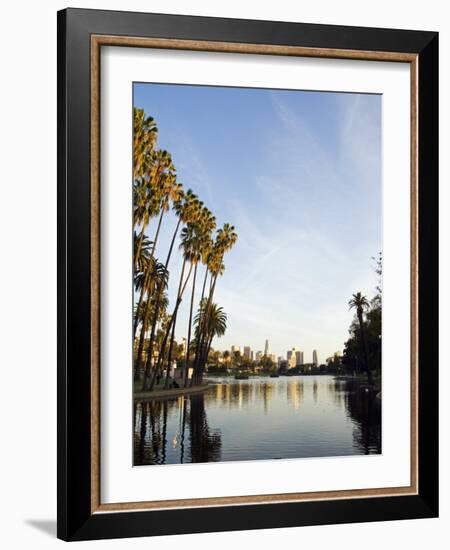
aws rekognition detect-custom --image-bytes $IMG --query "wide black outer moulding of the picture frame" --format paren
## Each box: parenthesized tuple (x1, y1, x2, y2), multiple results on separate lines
(57, 9, 438, 540)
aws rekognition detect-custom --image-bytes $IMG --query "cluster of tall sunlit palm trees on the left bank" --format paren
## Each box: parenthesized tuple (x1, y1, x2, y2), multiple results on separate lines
(133, 108, 237, 391)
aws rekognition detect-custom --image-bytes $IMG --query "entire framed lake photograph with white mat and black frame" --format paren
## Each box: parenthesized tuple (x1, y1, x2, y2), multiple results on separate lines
(58, 9, 438, 540)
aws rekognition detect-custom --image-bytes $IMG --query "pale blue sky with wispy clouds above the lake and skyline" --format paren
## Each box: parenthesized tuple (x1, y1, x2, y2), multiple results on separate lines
(134, 83, 382, 362)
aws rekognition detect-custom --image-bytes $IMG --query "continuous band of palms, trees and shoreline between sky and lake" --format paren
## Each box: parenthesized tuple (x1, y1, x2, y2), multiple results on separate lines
(133, 108, 382, 399)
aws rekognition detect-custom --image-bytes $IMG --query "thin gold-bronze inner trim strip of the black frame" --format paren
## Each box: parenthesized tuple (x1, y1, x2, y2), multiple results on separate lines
(90, 35, 419, 514)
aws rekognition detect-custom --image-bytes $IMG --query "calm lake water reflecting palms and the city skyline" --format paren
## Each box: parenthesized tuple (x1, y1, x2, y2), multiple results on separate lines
(134, 376, 381, 465)
